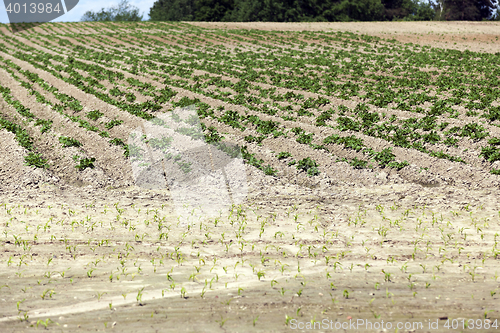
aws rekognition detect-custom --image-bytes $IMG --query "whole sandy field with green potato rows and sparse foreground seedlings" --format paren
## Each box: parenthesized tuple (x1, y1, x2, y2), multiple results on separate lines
(0, 22, 500, 332)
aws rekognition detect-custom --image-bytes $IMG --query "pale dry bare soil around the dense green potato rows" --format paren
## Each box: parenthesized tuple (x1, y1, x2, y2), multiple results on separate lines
(0, 22, 500, 332)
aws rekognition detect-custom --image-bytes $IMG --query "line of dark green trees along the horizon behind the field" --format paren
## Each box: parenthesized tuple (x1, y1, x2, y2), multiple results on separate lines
(82, 0, 500, 22)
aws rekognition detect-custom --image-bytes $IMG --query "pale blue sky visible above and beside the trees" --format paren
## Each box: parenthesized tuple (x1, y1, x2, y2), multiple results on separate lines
(0, 0, 156, 23)
